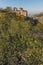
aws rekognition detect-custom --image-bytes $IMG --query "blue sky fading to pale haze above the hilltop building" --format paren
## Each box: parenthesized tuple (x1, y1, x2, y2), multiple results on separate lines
(0, 0, 43, 14)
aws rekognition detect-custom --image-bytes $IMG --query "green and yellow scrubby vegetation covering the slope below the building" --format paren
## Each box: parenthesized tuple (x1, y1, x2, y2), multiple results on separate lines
(0, 10, 43, 65)
